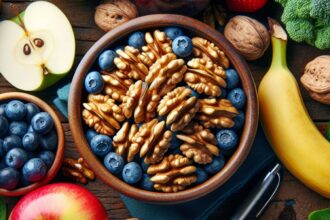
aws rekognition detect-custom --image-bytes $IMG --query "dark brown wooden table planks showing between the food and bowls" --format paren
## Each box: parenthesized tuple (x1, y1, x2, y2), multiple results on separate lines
(0, 0, 330, 220)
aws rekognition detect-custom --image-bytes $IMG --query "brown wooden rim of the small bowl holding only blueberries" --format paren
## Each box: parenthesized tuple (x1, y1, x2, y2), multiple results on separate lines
(0, 92, 64, 196)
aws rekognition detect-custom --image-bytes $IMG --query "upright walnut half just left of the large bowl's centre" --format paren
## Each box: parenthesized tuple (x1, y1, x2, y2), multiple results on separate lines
(121, 80, 160, 123)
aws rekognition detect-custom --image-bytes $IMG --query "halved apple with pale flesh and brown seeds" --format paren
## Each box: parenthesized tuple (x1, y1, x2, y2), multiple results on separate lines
(0, 1, 75, 91)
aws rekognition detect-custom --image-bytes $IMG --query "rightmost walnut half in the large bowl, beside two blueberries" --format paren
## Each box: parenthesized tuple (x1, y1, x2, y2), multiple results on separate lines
(196, 98, 238, 128)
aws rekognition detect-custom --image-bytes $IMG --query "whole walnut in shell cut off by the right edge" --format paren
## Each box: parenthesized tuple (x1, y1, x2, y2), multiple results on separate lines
(300, 55, 330, 105)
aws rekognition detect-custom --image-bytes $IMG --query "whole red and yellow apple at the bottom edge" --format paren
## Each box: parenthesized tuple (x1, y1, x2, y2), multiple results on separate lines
(9, 183, 109, 220)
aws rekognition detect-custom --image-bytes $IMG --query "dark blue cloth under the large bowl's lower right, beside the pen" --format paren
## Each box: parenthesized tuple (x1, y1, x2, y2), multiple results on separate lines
(121, 128, 275, 220)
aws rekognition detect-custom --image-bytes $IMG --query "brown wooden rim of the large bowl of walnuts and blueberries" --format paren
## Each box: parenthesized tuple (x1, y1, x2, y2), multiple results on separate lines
(69, 14, 258, 203)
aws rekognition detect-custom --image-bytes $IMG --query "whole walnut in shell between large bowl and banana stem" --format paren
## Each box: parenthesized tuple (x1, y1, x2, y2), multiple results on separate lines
(224, 16, 270, 60)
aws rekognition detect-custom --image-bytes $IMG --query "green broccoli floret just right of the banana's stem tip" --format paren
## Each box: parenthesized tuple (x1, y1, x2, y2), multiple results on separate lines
(286, 18, 315, 45)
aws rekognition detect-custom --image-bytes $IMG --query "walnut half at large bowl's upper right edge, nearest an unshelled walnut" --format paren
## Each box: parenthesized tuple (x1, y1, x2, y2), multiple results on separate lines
(192, 37, 229, 69)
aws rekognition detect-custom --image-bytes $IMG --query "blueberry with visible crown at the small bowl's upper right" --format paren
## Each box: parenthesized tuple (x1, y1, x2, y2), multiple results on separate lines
(31, 112, 54, 134)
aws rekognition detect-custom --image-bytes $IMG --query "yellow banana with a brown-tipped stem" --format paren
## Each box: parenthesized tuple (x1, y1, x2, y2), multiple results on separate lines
(258, 19, 330, 198)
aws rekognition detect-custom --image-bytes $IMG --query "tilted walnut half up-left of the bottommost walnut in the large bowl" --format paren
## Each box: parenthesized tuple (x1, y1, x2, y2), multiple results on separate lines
(127, 119, 172, 164)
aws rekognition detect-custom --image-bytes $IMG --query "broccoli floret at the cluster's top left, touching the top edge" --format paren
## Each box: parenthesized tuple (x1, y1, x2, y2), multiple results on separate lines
(281, 0, 311, 23)
